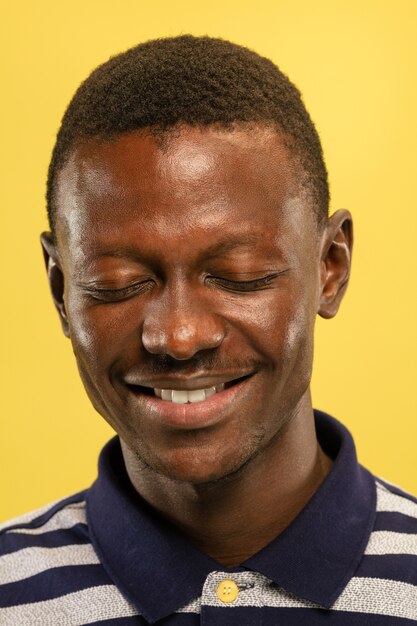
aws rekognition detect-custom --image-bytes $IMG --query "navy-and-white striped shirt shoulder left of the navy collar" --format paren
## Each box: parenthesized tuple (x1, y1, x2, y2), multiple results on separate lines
(0, 492, 137, 626)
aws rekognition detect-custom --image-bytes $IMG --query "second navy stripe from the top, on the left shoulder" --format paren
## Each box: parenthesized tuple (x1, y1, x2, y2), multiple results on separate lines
(0, 524, 90, 556)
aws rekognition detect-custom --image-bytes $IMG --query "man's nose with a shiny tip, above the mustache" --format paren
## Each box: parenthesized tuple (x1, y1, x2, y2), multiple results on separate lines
(142, 288, 225, 360)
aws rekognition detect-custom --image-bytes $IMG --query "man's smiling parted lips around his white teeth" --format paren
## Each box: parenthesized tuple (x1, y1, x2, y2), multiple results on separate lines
(123, 374, 252, 430)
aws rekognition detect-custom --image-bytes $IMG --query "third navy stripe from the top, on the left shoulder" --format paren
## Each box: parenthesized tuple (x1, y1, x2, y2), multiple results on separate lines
(0, 564, 113, 608)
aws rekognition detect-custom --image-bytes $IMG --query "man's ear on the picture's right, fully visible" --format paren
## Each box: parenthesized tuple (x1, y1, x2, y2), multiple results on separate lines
(318, 209, 353, 318)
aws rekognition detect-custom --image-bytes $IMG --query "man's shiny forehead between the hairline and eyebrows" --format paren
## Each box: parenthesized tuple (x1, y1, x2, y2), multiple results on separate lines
(56, 127, 311, 260)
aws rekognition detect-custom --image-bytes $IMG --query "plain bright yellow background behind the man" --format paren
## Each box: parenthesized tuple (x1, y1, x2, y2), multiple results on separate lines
(0, 0, 417, 519)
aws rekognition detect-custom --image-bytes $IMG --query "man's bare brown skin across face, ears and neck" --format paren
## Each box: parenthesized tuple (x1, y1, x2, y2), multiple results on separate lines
(41, 127, 352, 565)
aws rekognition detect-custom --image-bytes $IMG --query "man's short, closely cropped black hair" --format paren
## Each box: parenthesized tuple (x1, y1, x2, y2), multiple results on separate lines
(46, 35, 329, 233)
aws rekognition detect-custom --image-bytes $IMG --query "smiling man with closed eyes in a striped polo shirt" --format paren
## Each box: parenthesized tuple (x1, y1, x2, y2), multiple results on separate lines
(0, 36, 417, 626)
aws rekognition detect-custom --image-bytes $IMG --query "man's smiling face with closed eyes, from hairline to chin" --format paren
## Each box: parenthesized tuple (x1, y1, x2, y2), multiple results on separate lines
(51, 127, 320, 483)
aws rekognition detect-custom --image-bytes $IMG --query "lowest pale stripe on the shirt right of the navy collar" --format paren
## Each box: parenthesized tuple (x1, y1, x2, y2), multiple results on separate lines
(332, 577, 417, 620)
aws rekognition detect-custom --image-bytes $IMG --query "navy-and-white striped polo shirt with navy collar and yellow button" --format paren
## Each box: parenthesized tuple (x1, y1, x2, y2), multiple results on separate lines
(0, 411, 417, 626)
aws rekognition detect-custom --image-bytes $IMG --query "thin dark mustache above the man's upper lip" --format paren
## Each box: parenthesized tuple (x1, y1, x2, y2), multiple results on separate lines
(133, 352, 261, 378)
